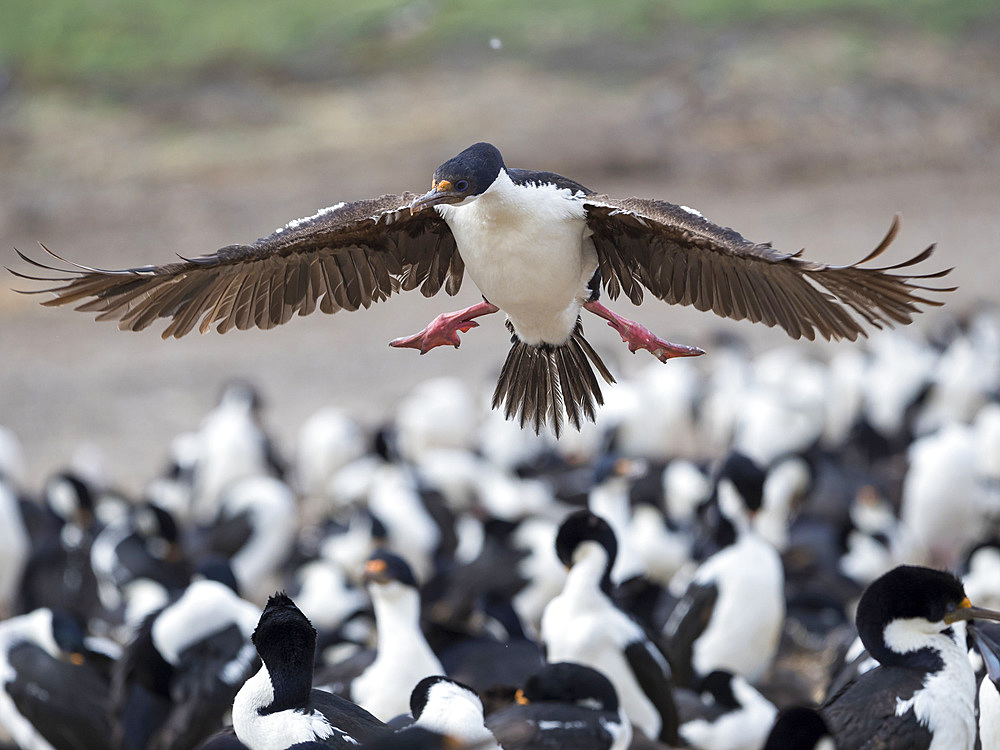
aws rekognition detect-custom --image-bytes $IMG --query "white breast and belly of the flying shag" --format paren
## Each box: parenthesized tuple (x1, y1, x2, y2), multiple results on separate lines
(438, 172, 597, 345)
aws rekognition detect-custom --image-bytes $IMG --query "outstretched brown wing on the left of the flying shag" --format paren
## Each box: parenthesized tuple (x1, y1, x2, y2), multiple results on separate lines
(8, 193, 464, 338)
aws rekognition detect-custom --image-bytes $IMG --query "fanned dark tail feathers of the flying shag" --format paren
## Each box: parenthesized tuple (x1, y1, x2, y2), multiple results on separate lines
(493, 318, 615, 437)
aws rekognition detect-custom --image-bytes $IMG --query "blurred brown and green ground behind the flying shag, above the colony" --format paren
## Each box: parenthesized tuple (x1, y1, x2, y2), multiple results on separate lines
(0, 0, 1000, 488)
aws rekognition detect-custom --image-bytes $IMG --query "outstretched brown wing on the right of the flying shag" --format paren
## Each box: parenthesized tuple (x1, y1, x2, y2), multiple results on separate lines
(586, 196, 953, 340)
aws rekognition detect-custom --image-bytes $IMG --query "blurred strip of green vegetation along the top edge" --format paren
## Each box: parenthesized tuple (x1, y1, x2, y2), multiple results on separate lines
(0, 0, 998, 81)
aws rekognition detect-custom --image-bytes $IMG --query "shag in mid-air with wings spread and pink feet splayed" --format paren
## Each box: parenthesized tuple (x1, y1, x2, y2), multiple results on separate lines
(11, 143, 950, 436)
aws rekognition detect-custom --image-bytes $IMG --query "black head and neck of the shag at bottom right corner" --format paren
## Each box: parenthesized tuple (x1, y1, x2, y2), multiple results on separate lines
(855, 565, 1000, 664)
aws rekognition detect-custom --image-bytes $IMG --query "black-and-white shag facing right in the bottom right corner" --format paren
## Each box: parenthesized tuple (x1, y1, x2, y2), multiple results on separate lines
(820, 565, 1000, 750)
